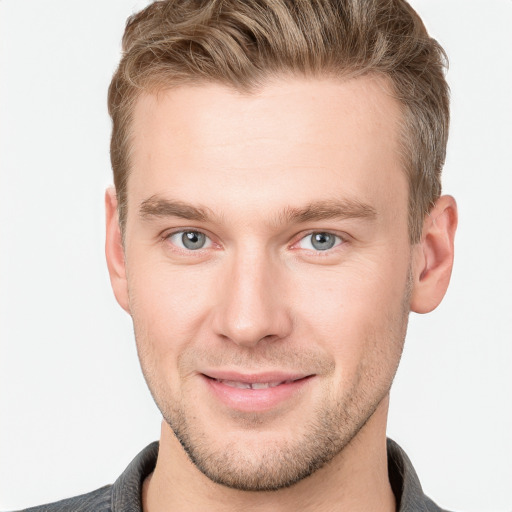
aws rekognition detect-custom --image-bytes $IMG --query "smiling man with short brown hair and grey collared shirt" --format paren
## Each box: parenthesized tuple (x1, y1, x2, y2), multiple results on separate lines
(22, 0, 457, 512)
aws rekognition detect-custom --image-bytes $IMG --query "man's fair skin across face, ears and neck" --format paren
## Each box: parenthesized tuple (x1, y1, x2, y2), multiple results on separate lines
(106, 76, 457, 512)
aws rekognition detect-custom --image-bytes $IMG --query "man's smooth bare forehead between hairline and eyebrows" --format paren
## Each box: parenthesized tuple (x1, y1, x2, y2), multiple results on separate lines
(128, 76, 405, 222)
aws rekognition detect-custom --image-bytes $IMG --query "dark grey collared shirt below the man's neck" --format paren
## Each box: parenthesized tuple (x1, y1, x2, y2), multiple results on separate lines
(21, 439, 445, 512)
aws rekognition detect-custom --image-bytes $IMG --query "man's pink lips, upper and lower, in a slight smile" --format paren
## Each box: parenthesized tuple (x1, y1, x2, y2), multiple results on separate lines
(200, 370, 314, 412)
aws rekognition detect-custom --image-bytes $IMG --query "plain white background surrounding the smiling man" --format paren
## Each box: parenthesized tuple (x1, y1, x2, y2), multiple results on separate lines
(0, 0, 512, 512)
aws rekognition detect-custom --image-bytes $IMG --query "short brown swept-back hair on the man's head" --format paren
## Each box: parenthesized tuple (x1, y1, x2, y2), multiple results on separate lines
(108, 0, 449, 243)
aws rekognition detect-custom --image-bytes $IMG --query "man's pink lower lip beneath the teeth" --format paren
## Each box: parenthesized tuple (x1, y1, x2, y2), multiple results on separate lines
(203, 375, 313, 412)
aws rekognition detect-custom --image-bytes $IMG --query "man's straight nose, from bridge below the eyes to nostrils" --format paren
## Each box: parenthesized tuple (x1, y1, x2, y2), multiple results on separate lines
(213, 247, 292, 347)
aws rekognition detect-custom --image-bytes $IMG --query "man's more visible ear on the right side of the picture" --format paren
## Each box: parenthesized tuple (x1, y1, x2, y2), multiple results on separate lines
(411, 196, 457, 313)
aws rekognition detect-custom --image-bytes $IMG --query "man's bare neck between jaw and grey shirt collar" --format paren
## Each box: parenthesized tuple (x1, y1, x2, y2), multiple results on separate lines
(143, 397, 396, 512)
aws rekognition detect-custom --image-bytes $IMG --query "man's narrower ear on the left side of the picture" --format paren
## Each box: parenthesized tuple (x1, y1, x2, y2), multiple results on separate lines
(105, 187, 130, 313)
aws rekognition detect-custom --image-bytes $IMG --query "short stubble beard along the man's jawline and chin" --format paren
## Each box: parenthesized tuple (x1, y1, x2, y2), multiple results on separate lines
(137, 273, 412, 492)
